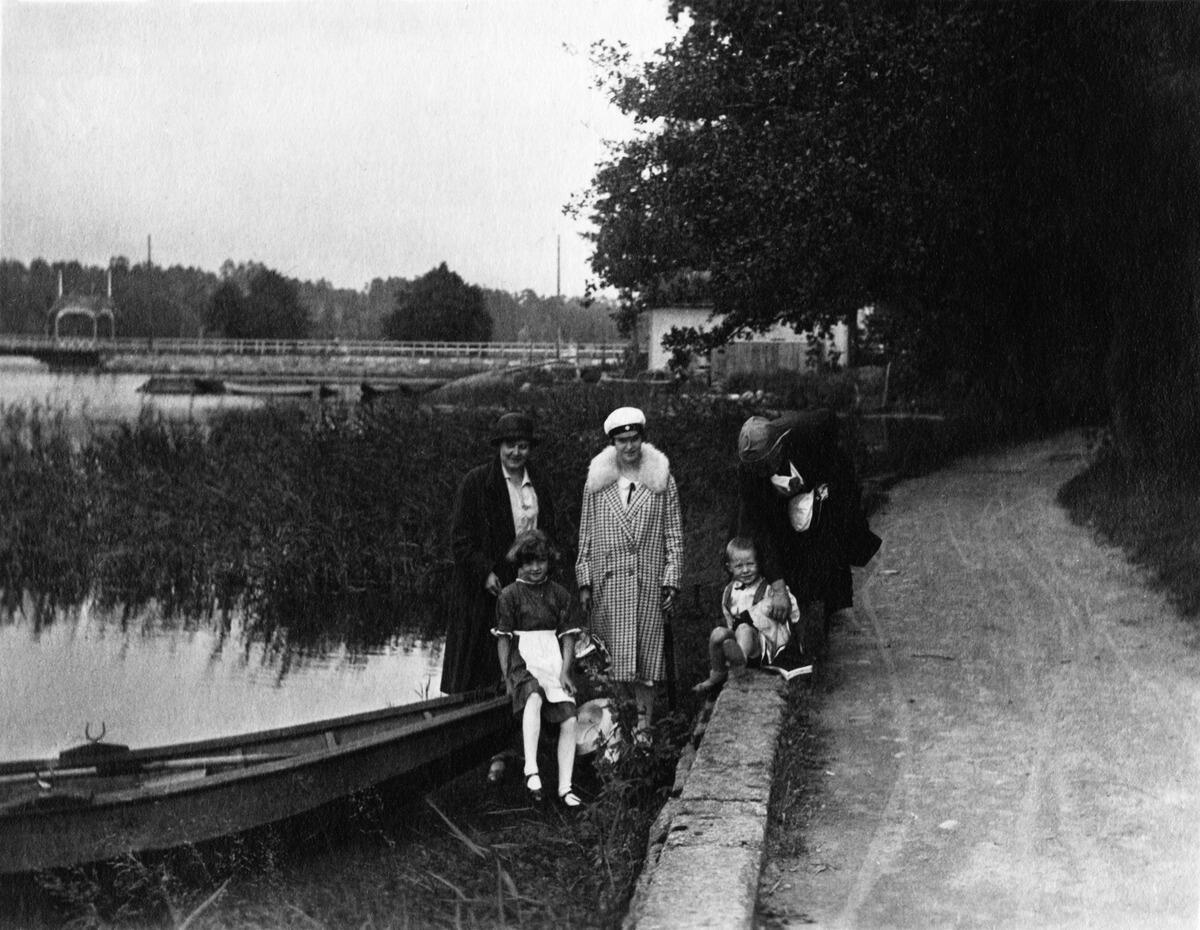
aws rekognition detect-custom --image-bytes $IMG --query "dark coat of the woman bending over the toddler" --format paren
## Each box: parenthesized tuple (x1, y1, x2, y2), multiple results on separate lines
(737, 410, 877, 613)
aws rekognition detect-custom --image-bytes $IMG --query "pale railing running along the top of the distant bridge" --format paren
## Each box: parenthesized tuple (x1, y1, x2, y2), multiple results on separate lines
(0, 334, 624, 364)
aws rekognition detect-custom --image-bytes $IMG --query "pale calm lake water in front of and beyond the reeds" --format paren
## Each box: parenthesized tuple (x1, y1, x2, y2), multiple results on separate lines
(0, 359, 442, 758)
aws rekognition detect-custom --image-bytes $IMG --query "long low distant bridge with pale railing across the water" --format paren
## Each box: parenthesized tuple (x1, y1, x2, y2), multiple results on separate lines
(0, 334, 625, 368)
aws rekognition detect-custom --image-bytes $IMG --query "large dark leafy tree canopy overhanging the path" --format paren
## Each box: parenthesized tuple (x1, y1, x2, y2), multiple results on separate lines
(580, 0, 1200, 448)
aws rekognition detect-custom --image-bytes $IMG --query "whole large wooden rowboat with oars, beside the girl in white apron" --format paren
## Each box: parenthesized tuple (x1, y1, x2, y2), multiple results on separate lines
(0, 694, 512, 875)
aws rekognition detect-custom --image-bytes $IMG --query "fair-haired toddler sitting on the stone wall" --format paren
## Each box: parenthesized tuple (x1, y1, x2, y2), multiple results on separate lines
(692, 536, 800, 694)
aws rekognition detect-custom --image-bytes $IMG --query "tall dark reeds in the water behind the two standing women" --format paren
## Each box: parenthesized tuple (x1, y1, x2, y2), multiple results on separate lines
(0, 385, 745, 647)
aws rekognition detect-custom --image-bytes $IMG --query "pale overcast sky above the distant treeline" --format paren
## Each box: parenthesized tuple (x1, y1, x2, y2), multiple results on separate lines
(0, 0, 673, 295)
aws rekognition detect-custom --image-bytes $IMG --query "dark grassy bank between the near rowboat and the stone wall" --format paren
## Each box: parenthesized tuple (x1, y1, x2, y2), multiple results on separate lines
(0, 754, 696, 930)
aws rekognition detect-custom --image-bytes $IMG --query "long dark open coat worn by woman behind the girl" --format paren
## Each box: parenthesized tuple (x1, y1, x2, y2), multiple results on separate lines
(442, 456, 554, 695)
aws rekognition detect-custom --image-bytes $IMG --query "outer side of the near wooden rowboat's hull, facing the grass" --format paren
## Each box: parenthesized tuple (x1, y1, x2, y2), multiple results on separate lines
(0, 696, 512, 874)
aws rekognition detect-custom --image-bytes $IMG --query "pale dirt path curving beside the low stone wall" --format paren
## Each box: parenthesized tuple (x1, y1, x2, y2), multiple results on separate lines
(760, 436, 1200, 930)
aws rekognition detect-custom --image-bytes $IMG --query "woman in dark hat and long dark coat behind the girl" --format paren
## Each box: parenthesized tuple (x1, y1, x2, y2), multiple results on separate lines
(442, 413, 554, 694)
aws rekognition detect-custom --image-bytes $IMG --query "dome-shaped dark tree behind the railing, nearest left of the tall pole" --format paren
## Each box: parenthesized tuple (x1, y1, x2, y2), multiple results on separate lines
(384, 262, 492, 342)
